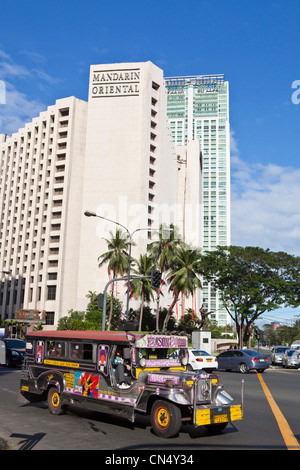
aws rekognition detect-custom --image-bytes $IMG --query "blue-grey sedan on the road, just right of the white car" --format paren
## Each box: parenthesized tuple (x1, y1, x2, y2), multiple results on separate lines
(217, 349, 269, 374)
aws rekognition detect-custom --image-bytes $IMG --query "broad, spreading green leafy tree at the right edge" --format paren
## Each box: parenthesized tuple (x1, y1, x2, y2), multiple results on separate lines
(201, 246, 300, 343)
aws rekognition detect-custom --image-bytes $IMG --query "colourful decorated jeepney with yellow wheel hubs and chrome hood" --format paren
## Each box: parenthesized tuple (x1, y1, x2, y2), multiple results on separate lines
(20, 330, 242, 438)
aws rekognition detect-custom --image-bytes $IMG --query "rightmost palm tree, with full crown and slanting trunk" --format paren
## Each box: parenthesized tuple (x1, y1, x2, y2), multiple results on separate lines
(163, 244, 201, 331)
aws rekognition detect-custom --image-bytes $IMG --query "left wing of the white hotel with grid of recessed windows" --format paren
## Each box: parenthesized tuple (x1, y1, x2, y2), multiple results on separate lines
(0, 98, 87, 324)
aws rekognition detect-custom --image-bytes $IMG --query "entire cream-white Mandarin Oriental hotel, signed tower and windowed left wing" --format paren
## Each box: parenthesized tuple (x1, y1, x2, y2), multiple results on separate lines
(0, 62, 177, 325)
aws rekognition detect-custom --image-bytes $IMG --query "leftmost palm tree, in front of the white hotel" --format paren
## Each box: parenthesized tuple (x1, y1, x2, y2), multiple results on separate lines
(98, 229, 129, 330)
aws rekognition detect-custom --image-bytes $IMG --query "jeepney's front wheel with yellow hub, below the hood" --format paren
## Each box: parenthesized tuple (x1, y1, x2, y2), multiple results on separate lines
(150, 400, 181, 439)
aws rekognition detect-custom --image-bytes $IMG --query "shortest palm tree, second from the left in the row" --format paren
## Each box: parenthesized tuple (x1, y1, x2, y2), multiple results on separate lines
(131, 254, 154, 331)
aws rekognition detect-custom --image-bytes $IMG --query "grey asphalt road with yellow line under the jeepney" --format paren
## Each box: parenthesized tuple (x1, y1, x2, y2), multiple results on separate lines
(0, 367, 300, 455)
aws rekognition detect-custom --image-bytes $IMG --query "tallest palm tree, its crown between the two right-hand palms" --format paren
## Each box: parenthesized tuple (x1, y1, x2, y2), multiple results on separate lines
(147, 224, 181, 331)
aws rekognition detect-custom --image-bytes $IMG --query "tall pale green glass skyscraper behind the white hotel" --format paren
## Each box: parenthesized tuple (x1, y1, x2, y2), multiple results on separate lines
(165, 75, 230, 326)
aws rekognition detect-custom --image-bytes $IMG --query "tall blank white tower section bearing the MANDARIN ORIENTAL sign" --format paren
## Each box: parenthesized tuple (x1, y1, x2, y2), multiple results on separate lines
(77, 62, 177, 310)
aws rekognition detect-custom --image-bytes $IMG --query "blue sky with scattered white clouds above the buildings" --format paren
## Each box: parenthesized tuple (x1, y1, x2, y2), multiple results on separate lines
(0, 0, 300, 324)
